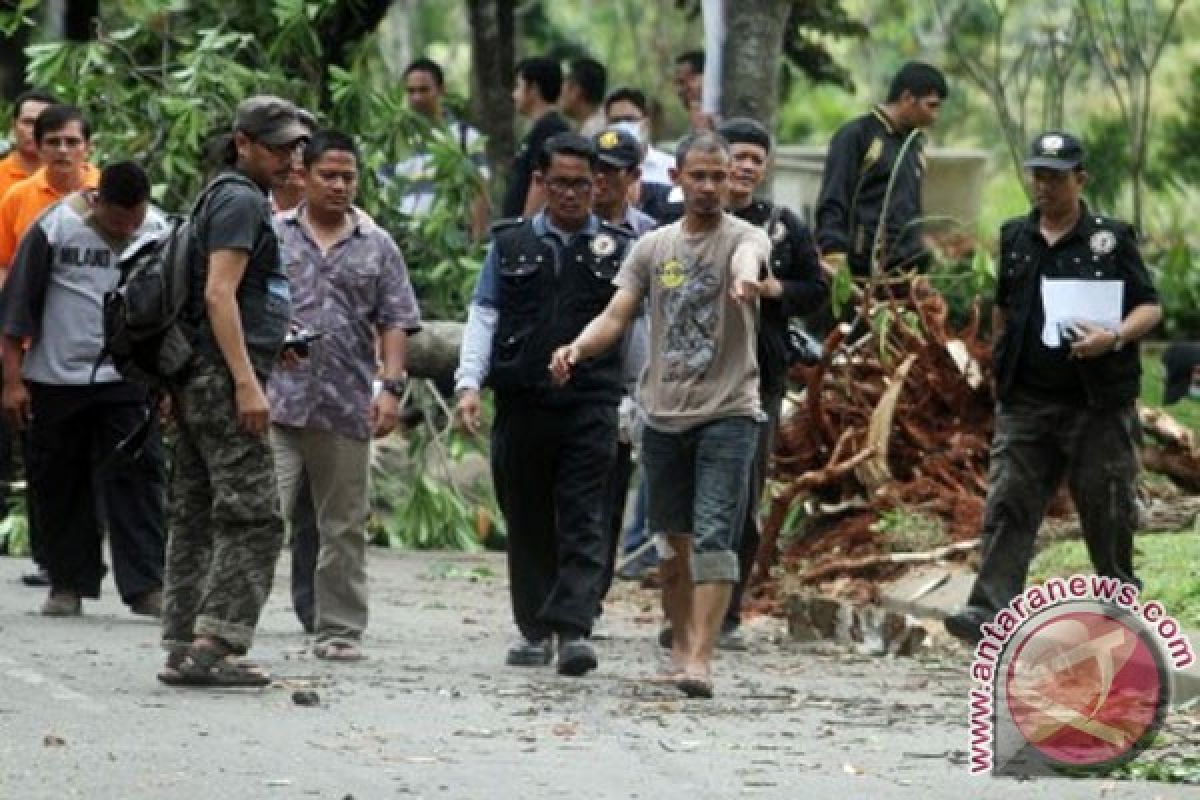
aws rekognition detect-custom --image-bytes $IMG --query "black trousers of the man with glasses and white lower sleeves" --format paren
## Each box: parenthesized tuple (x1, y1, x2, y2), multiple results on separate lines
(492, 396, 617, 640)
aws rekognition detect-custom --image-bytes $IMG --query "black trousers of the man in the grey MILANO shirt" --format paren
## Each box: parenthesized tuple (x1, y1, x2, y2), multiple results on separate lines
(28, 384, 167, 603)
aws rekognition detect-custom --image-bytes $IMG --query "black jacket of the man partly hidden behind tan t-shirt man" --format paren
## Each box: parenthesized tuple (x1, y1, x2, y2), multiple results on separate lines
(733, 200, 829, 396)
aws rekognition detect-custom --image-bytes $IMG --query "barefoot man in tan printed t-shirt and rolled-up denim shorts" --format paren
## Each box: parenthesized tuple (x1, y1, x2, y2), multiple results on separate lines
(550, 133, 770, 697)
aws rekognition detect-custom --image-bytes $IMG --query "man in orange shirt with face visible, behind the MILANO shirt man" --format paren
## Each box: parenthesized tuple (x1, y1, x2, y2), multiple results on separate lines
(0, 106, 100, 273)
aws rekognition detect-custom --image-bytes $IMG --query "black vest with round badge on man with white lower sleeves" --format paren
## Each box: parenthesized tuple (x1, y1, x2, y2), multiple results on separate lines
(487, 219, 632, 405)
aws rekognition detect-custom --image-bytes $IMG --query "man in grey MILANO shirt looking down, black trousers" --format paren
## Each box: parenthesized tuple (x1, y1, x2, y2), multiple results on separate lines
(2, 162, 167, 616)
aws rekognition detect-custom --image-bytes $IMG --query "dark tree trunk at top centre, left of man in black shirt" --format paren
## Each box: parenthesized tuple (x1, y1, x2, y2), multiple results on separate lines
(467, 0, 516, 215)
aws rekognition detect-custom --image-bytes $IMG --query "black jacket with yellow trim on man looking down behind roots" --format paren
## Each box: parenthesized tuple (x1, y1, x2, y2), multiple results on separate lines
(816, 107, 928, 275)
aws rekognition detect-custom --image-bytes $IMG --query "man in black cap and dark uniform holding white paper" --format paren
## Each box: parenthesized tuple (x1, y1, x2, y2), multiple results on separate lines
(946, 131, 1163, 642)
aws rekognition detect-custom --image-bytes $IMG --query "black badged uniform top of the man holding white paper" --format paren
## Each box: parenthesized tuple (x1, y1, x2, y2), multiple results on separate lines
(994, 205, 1158, 408)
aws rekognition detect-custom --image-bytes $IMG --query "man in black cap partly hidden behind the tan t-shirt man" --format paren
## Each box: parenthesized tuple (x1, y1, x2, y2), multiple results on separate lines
(716, 116, 829, 649)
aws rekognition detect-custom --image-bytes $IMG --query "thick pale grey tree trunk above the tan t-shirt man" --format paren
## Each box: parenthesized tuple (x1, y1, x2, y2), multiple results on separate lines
(721, 0, 792, 131)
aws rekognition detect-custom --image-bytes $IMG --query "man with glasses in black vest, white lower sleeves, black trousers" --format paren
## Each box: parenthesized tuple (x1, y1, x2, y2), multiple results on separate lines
(456, 133, 631, 675)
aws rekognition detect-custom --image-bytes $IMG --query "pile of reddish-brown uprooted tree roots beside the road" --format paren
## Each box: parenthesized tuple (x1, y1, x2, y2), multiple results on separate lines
(752, 278, 1200, 607)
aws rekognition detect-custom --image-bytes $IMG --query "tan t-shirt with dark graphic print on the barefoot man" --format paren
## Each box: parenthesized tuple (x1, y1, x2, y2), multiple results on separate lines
(613, 213, 770, 433)
